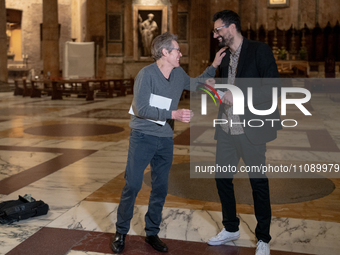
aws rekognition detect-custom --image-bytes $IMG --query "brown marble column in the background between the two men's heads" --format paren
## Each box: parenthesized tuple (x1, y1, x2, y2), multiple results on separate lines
(189, 0, 211, 77)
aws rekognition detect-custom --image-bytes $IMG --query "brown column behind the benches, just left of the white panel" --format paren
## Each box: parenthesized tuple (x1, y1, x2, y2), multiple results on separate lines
(42, 0, 60, 77)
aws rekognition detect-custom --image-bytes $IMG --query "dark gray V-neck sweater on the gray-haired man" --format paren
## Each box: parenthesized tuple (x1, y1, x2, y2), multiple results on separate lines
(130, 62, 216, 137)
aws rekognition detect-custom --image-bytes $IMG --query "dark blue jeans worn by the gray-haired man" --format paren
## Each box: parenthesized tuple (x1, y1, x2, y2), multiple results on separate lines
(116, 129, 174, 236)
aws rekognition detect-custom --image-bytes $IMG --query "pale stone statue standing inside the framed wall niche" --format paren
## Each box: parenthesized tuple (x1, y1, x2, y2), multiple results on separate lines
(138, 13, 158, 56)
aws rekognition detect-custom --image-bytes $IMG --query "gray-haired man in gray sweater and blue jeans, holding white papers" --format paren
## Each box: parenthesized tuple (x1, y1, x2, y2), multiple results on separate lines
(111, 33, 225, 253)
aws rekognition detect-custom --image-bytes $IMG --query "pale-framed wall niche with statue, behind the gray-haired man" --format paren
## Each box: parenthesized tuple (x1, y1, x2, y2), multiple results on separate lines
(133, 4, 168, 61)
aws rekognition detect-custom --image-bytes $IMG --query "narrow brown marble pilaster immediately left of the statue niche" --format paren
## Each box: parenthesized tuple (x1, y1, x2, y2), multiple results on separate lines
(124, 0, 133, 60)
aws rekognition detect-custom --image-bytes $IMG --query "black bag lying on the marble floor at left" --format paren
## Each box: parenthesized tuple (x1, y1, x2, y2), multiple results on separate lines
(0, 195, 49, 224)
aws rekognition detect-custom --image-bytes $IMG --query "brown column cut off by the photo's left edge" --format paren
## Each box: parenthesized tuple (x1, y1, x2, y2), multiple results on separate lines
(0, 0, 8, 85)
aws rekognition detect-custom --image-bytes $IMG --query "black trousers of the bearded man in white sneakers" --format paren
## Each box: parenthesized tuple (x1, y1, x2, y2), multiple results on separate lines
(215, 129, 271, 243)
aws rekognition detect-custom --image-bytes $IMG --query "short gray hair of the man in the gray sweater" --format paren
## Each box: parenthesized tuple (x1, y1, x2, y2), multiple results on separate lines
(151, 32, 177, 61)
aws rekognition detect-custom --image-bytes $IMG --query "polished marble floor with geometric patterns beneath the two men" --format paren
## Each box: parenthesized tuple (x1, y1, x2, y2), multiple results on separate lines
(0, 86, 340, 255)
